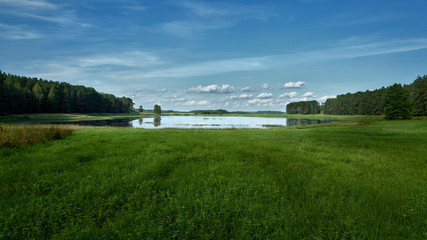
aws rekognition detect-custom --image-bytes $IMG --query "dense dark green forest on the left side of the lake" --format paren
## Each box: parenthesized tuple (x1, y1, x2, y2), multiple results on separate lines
(0, 71, 134, 115)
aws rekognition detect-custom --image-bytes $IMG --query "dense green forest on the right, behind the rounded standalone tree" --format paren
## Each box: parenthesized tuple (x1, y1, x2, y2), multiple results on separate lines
(324, 75, 427, 116)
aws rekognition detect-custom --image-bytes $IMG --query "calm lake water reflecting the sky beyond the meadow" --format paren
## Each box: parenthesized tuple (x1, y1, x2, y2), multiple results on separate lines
(60, 116, 330, 129)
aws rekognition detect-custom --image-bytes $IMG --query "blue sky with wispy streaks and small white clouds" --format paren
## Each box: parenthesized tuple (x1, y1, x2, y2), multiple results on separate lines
(0, 0, 427, 111)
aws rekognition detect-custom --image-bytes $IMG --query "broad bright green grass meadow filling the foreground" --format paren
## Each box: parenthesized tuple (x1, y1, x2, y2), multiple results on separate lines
(0, 120, 427, 239)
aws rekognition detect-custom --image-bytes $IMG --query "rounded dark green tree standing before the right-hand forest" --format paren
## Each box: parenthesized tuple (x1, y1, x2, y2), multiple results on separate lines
(384, 83, 411, 120)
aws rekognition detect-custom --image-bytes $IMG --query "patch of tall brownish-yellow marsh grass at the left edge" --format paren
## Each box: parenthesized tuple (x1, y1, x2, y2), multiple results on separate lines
(0, 124, 78, 147)
